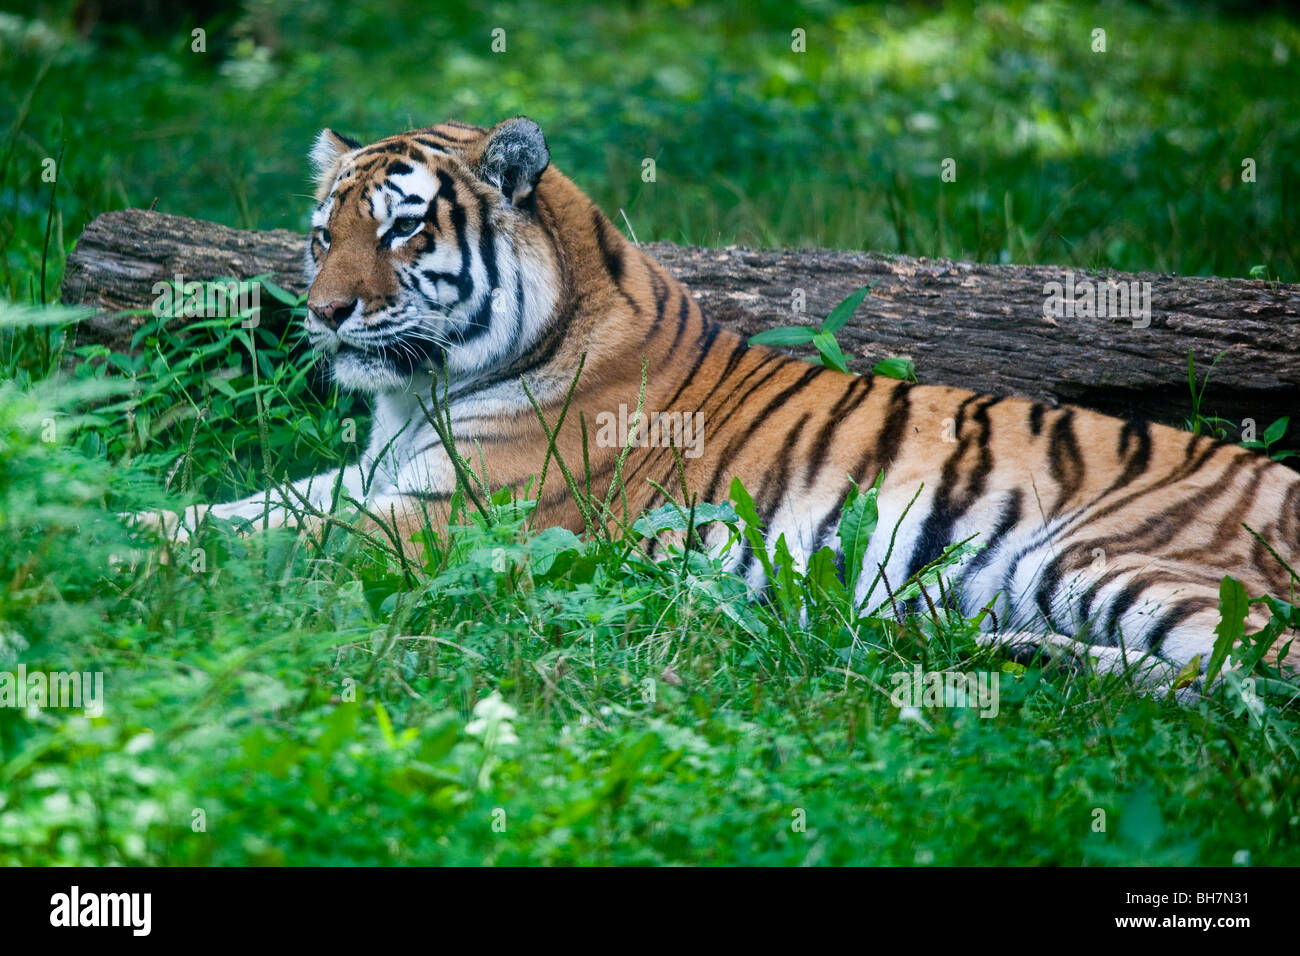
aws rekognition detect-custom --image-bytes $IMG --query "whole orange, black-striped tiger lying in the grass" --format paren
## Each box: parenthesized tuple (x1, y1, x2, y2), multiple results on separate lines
(170, 116, 1300, 674)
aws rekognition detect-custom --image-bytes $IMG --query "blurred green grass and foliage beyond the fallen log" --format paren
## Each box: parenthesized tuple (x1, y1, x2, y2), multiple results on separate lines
(0, 0, 1300, 295)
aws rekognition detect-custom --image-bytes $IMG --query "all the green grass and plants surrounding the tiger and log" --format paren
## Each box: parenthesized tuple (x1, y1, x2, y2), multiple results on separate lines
(0, 4, 1300, 865)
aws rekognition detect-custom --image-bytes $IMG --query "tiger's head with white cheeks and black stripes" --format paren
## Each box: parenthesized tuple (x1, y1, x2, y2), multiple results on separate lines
(306, 117, 559, 393)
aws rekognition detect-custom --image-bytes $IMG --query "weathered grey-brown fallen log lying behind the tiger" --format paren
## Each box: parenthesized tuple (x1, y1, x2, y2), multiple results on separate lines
(62, 209, 1300, 432)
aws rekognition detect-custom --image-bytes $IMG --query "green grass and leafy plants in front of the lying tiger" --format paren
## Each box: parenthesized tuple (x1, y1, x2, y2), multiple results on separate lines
(0, 290, 1300, 865)
